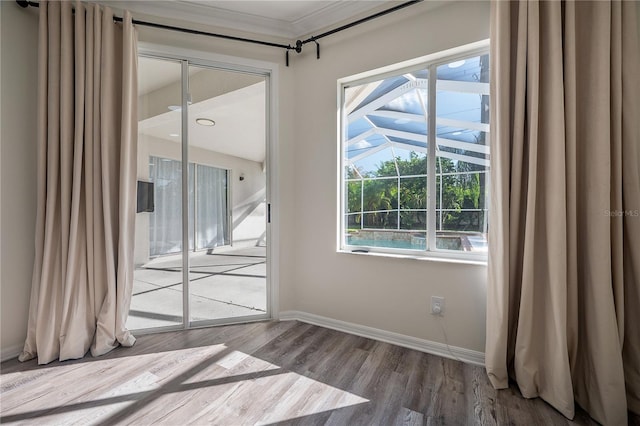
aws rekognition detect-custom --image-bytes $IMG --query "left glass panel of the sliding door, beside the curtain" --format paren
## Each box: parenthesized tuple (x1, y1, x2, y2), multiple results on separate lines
(127, 57, 184, 329)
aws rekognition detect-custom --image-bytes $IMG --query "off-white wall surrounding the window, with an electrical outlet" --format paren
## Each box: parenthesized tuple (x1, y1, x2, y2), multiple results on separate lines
(291, 2, 489, 352)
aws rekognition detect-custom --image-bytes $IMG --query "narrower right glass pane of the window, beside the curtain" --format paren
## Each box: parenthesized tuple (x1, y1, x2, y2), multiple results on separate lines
(435, 55, 489, 252)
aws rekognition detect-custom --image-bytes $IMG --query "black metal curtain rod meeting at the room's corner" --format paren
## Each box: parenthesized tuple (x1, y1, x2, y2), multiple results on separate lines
(16, 0, 423, 66)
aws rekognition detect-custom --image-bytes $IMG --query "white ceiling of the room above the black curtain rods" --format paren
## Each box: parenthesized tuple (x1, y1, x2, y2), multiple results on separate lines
(106, 0, 390, 40)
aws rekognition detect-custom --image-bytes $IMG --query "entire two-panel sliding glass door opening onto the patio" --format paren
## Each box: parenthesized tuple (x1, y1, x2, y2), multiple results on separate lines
(127, 56, 269, 331)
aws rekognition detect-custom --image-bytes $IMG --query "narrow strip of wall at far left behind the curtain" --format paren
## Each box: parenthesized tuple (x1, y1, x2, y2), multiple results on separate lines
(0, 1, 38, 359)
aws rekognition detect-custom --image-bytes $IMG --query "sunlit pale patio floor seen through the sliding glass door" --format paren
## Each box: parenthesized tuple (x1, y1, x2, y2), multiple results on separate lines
(127, 247, 267, 330)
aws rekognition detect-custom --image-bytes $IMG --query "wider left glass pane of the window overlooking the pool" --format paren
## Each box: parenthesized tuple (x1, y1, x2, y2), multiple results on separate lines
(343, 69, 428, 250)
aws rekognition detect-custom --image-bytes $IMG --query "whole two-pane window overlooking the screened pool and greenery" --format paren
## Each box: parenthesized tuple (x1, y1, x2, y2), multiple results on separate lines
(340, 50, 489, 258)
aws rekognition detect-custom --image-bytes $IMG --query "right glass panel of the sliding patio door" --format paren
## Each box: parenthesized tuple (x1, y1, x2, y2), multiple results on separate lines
(188, 65, 267, 325)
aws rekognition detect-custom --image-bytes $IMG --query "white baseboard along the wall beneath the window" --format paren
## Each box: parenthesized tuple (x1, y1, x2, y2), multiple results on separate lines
(279, 311, 484, 367)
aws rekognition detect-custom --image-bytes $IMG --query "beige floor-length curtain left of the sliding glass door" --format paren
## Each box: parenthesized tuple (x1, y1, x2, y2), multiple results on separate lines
(19, 1, 137, 364)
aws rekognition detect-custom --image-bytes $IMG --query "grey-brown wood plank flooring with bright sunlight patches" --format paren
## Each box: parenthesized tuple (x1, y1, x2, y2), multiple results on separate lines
(0, 321, 635, 425)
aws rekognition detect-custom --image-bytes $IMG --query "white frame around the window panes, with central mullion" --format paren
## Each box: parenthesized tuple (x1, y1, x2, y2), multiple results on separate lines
(336, 39, 491, 264)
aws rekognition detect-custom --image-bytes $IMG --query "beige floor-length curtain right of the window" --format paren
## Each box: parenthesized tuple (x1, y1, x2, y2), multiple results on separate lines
(486, 0, 640, 425)
